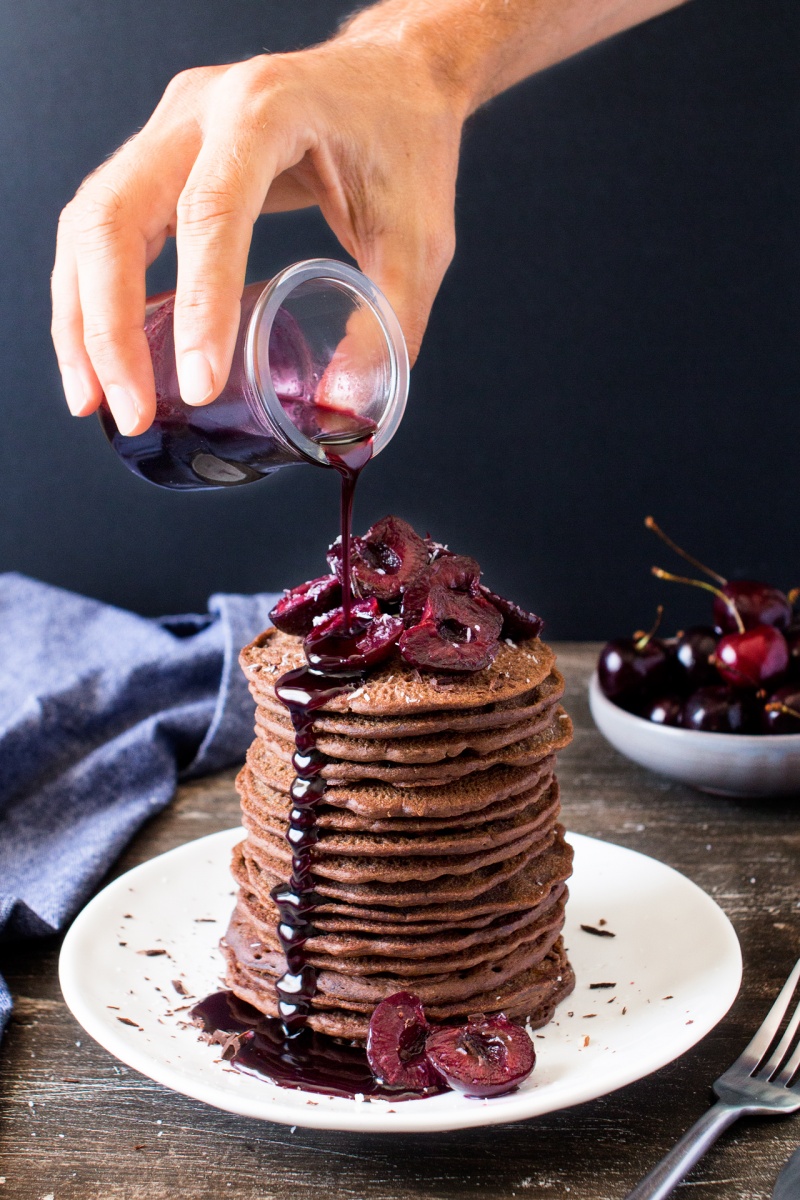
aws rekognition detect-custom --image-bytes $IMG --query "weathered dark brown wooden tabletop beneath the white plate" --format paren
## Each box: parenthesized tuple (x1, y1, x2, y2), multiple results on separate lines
(0, 643, 800, 1200)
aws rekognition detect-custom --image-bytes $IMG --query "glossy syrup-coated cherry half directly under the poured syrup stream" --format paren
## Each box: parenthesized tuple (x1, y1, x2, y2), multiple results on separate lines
(302, 596, 403, 672)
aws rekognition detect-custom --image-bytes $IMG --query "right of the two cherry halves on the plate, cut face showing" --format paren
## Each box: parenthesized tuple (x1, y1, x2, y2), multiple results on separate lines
(425, 1013, 536, 1098)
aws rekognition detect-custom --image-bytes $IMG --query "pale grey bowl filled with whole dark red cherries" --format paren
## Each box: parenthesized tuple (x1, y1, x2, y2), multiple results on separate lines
(589, 517, 800, 797)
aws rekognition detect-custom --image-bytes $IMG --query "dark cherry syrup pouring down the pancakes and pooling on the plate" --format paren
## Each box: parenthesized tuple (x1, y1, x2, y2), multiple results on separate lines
(191, 433, 445, 1100)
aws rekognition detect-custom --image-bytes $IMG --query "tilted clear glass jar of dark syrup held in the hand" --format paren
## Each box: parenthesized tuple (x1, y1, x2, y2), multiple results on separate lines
(98, 258, 409, 490)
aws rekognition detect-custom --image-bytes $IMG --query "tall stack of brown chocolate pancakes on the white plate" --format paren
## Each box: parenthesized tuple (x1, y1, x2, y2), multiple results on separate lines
(223, 629, 573, 1040)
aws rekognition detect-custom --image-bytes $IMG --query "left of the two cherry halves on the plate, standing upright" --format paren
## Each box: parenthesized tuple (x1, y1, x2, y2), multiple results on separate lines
(367, 991, 441, 1092)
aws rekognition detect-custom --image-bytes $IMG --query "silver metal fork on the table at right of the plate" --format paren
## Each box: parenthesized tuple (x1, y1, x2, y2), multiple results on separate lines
(626, 960, 800, 1200)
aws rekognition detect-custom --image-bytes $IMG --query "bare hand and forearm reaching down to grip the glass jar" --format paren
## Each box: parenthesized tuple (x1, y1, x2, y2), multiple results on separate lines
(53, 0, 681, 433)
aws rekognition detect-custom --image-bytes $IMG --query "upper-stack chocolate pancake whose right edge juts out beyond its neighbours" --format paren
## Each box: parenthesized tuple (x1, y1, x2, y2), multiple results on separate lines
(257, 707, 572, 787)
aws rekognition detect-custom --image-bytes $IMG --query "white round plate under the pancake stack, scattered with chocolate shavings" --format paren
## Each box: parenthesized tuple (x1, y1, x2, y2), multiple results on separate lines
(60, 829, 741, 1133)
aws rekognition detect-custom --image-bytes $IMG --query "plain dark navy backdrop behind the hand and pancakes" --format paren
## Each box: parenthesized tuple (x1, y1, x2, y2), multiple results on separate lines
(0, 0, 800, 637)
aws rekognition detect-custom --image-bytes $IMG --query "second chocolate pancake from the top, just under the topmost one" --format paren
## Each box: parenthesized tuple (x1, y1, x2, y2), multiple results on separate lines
(249, 670, 564, 752)
